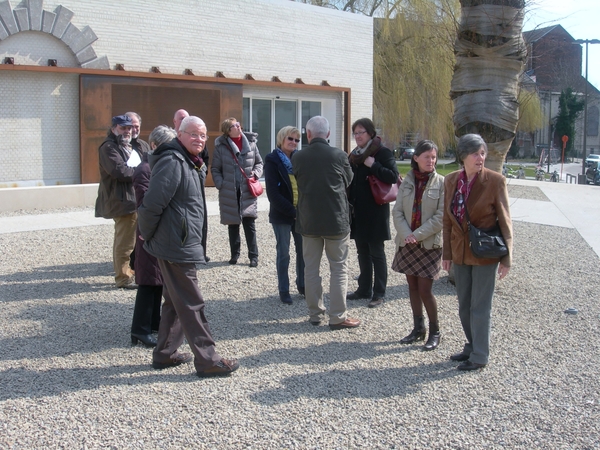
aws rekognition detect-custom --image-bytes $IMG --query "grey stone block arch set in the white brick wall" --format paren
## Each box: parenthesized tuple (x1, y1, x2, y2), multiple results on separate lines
(0, 0, 110, 69)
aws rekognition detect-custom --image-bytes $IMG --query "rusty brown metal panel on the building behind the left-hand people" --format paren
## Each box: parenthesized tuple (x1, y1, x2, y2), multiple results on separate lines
(80, 75, 243, 186)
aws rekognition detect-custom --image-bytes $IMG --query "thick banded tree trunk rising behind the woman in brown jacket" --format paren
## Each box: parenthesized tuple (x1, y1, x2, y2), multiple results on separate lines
(450, 0, 527, 172)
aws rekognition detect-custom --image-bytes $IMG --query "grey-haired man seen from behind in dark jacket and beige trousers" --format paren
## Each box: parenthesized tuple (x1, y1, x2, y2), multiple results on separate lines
(292, 116, 360, 330)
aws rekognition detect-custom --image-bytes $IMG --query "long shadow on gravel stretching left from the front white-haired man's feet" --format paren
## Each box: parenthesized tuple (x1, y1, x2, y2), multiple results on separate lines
(0, 364, 198, 401)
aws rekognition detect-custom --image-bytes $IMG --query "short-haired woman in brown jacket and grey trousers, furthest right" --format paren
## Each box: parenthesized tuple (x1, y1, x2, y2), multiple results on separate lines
(442, 134, 512, 370)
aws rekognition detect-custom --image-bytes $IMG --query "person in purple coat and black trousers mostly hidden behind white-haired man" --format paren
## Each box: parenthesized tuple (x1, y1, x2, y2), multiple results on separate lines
(131, 125, 177, 347)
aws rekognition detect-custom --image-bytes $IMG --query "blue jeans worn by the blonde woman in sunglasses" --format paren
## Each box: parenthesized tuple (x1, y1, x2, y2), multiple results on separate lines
(271, 223, 304, 292)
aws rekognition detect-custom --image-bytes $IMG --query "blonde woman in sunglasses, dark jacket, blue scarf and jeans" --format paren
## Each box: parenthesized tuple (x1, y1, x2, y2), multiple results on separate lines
(264, 126, 304, 304)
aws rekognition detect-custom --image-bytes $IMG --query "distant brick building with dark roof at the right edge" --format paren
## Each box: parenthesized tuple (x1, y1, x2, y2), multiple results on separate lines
(517, 25, 600, 158)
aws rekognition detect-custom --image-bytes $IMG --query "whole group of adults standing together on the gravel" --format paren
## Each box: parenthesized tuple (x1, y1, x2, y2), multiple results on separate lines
(96, 110, 512, 377)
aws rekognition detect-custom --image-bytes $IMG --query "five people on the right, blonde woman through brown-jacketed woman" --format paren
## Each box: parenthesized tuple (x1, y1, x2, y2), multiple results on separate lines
(265, 116, 512, 371)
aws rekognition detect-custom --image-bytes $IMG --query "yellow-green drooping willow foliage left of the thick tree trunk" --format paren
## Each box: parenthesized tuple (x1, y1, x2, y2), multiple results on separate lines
(373, 0, 459, 149)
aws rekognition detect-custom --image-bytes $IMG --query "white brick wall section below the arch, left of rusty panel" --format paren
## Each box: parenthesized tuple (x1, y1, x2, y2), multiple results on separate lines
(0, 71, 81, 188)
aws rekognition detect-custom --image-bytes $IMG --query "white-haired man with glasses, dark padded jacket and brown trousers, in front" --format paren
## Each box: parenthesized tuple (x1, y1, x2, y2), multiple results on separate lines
(138, 116, 239, 377)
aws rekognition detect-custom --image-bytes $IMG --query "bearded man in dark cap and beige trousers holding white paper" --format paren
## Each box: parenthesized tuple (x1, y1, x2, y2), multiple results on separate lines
(96, 115, 142, 289)
